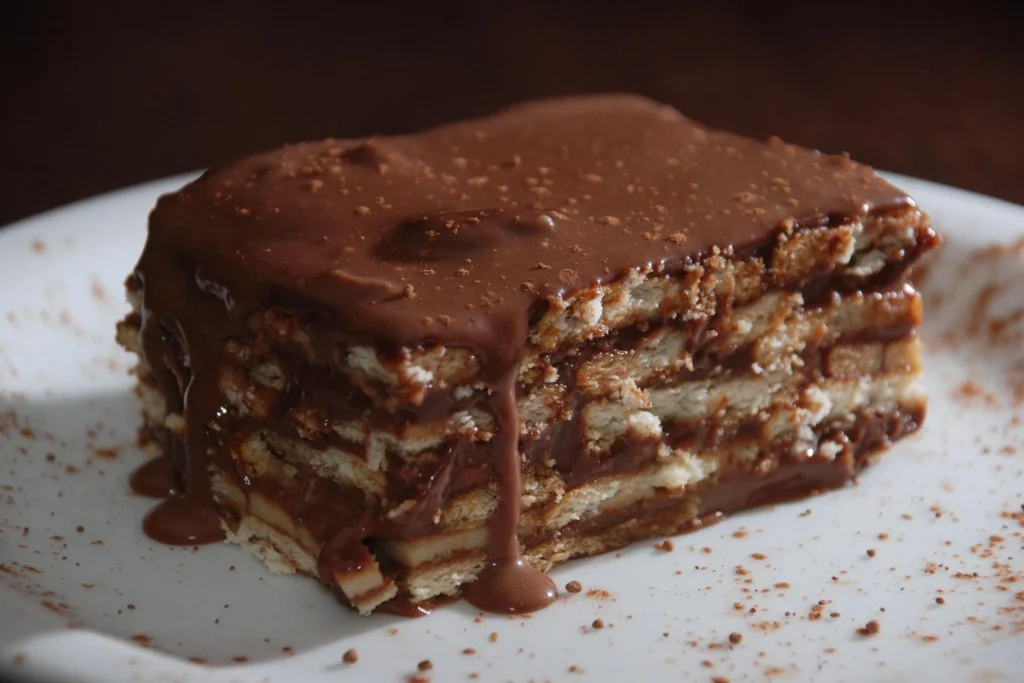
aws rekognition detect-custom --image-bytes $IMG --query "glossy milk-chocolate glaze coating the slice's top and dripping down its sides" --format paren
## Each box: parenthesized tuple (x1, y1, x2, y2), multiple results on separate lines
(123, 95, 911, 611)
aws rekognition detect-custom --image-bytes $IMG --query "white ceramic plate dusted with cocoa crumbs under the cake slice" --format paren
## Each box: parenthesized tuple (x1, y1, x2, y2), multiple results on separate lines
(0, 178, 1024, 683)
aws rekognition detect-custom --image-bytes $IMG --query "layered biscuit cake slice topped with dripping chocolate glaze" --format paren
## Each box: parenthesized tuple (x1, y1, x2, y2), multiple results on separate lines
(119, 95, 937, 612)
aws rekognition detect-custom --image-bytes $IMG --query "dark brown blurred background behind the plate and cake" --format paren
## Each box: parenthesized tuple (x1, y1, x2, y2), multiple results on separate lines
(0, 0, 1024, 224)
